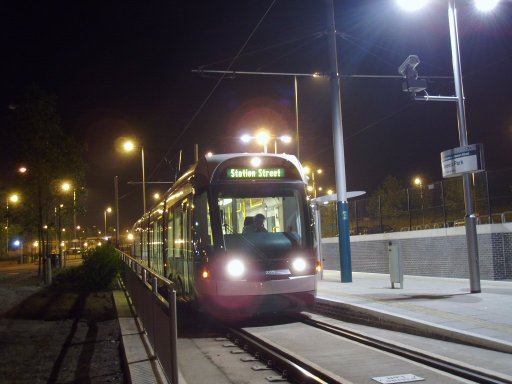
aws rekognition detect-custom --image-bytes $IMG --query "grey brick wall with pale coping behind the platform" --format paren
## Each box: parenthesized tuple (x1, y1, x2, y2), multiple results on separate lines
(322, 223, 512, 280)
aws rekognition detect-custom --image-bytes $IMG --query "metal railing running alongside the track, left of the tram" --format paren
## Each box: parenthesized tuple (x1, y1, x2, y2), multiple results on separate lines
(118, 250, 178, 384)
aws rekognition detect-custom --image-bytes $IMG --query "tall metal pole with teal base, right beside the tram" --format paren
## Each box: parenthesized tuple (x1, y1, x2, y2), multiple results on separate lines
(326, 0, 352, 283)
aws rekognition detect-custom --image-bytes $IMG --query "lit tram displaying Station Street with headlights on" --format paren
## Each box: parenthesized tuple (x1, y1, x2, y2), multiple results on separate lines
(133, 153, 318, 317)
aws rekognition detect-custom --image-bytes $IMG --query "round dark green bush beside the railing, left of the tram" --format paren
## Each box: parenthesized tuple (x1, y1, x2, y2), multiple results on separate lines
(82, 244, 121, 291)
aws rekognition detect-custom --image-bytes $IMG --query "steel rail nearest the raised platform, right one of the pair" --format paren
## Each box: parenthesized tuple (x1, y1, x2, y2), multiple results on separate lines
(302, 319, 512, 384)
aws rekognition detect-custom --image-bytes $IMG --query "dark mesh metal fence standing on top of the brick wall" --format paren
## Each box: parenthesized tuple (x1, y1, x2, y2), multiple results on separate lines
(319, 170, 512, 237)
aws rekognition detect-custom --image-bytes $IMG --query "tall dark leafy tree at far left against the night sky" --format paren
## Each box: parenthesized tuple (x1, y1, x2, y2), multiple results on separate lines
(11, 85, 85, 268)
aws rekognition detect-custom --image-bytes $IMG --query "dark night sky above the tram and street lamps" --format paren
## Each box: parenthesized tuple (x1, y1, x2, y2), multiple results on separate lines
(4, 0, 512, 229)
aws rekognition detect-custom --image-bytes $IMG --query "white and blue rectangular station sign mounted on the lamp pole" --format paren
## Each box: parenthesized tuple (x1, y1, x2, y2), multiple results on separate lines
(441, 144, 485, 178)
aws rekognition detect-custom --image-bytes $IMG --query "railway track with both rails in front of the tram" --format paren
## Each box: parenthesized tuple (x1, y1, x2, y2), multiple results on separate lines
(223, 319, 512, 384)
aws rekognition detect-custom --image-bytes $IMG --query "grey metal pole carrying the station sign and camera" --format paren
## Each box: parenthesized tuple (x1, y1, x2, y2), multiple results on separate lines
(448, 0, 481, 293)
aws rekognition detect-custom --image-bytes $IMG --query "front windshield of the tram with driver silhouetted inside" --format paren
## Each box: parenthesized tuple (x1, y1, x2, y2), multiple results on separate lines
(218, 189, 305, 249)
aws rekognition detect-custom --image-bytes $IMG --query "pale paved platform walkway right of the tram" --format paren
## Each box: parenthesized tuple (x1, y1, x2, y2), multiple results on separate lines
(317, 271, 512, 353)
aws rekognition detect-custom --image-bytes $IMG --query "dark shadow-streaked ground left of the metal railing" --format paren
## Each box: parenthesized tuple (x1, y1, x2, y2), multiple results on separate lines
(0, 260, 126, 383)
